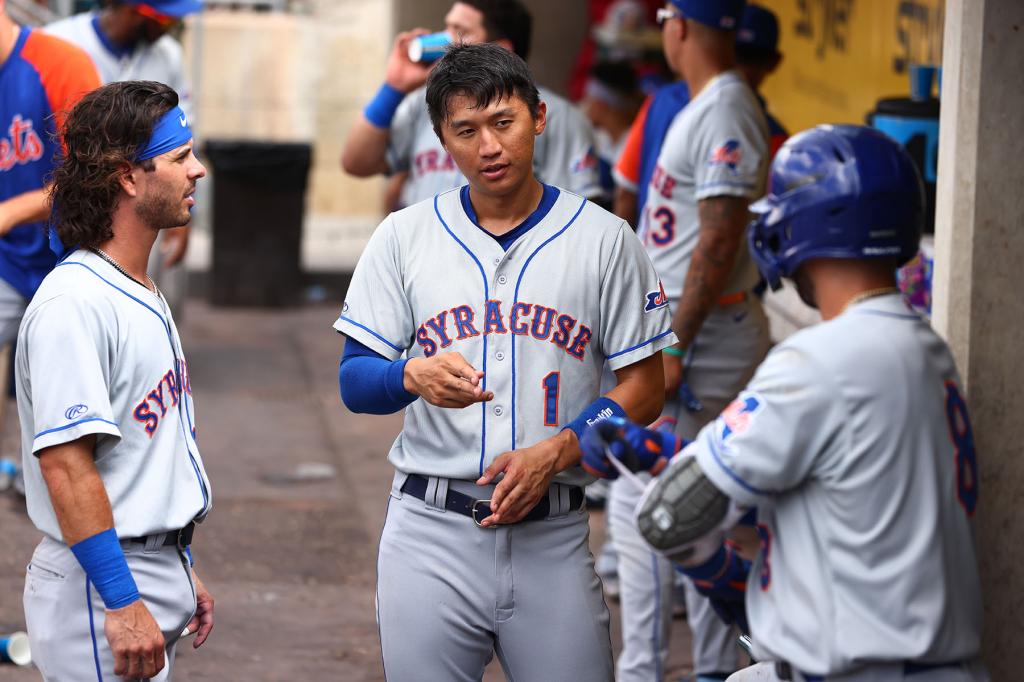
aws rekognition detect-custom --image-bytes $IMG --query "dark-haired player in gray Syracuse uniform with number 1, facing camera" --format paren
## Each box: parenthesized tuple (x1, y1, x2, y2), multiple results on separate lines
(335, 44, 674, 681)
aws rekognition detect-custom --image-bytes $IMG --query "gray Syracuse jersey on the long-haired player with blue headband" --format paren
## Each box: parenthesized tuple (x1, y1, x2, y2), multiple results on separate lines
(15, 250, 211, 541)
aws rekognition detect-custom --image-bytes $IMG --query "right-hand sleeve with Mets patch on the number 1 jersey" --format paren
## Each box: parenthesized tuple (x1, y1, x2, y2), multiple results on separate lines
(601, 221, 676, 370)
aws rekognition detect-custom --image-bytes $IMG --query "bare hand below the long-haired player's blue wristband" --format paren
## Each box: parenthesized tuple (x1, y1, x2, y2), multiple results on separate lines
(103, 599, 166, 680)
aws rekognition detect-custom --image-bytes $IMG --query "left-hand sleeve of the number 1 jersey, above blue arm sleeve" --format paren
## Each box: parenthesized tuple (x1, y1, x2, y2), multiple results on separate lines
(334, 216, 416, 360)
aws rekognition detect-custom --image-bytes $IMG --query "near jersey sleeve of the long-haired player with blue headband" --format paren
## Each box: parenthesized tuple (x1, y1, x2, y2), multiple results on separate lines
(18, 295, 121, 454)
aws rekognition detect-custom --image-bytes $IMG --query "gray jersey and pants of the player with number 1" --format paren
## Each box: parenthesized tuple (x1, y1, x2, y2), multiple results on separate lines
(335, 187, 675, 681)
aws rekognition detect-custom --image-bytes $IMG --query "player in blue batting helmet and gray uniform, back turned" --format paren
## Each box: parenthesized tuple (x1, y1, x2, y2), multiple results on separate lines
(584, 126, 987, 682)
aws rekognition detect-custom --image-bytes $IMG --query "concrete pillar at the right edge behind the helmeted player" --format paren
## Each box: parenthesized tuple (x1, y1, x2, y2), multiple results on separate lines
(933, 0, 1024, 680)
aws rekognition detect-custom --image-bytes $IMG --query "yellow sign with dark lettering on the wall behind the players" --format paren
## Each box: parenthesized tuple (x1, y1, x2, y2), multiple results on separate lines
(754, 0, 945, 133)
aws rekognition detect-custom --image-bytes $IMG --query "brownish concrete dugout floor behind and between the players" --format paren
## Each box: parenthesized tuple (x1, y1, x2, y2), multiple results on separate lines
(0, 301, 690, 682)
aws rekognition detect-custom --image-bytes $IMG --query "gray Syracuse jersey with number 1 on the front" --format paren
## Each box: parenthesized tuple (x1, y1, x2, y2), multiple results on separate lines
(335, 189, 675, 484)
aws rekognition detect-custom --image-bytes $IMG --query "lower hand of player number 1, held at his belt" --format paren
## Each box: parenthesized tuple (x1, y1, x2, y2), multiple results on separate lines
(476, 429, 579, 527)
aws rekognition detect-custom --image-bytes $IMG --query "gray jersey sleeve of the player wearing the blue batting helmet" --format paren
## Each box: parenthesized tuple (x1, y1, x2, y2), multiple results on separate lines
(691, 346, 844, 506)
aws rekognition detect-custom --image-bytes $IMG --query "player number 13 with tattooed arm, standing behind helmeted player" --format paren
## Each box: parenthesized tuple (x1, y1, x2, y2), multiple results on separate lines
(608, 0, 769, 682)
